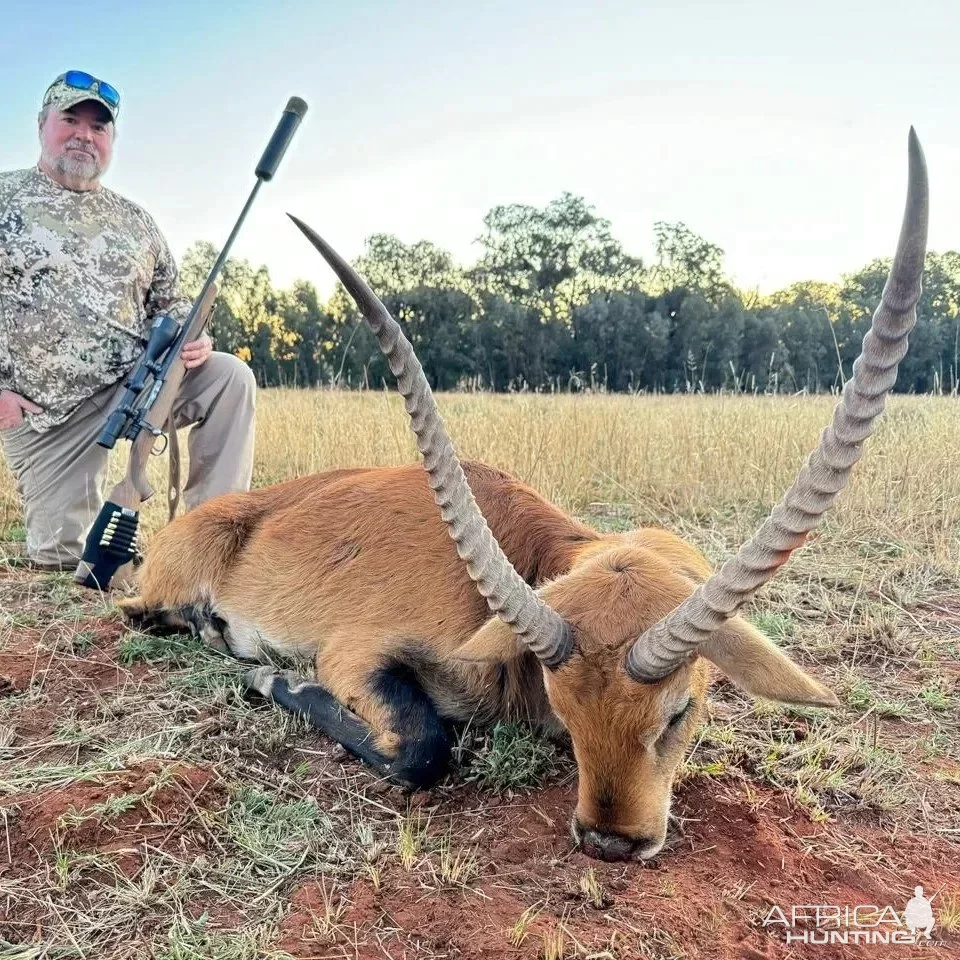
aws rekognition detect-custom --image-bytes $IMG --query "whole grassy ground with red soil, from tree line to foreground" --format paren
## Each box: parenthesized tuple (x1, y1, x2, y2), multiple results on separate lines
(0, 390, 960, 960)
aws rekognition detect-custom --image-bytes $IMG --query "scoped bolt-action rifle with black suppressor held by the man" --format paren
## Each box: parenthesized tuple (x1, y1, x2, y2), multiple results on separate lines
(74, 97, 307, 590)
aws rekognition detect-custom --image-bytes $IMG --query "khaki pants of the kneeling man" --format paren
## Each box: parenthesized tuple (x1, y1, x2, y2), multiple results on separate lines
(0, 353, 256, 569)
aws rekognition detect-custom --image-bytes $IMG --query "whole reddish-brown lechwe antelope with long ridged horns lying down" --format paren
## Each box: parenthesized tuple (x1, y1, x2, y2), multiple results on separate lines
(116, 129, 928, 859)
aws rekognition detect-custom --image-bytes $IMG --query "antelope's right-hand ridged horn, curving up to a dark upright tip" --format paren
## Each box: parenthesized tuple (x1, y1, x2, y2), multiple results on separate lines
(626, 127, 929, 681)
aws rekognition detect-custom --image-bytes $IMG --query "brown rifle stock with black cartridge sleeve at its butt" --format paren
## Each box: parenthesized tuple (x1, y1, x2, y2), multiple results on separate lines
(74, 283, 217, 589)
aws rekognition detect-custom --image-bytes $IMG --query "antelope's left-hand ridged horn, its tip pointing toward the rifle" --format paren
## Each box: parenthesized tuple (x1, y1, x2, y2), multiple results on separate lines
(287, 214, 573, 668)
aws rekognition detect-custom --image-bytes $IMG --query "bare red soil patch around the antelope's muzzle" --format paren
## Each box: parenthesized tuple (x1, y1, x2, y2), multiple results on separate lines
(278, 783, 960, 960)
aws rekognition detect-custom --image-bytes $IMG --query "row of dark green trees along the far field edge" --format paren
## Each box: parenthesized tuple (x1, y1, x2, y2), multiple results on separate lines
(181, 193, 960, 393)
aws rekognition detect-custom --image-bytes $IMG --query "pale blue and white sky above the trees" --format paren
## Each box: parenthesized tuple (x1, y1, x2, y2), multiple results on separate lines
(0, 0, 960, 295)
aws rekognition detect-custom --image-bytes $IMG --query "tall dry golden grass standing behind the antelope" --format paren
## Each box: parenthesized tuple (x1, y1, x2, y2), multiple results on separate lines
(0, 390, 960, 560)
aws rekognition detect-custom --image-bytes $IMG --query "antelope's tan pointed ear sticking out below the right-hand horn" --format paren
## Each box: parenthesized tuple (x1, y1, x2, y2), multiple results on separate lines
(697, 617, 840, 707)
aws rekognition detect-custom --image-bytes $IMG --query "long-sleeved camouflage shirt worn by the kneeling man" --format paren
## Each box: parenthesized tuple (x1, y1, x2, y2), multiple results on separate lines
(0, 167, 190, 431)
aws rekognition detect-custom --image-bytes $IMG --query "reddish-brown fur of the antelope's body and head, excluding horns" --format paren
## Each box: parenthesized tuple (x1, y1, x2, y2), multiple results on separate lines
(124, 462, 834, 857)
